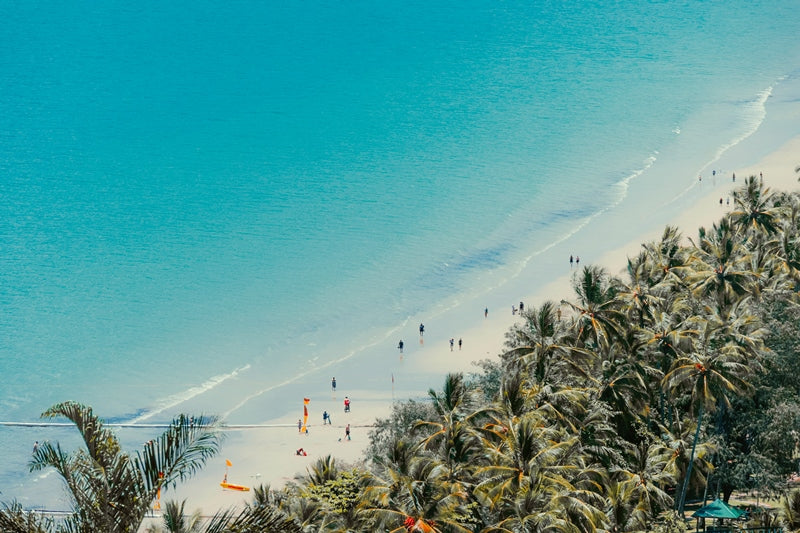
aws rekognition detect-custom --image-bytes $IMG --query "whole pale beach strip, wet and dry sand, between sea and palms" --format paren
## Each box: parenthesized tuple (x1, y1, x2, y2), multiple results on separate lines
(12, 81, 800, 514)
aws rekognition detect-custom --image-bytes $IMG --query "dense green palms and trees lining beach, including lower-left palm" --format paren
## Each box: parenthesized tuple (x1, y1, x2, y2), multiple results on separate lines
(0, 176, 800, 533)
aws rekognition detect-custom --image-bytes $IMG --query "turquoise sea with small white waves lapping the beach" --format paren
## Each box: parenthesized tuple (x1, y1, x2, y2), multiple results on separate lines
(0, 0, 800, 504)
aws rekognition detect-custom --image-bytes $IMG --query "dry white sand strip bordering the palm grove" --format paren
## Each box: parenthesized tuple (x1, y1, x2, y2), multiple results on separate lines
(153, 119, 800, 514)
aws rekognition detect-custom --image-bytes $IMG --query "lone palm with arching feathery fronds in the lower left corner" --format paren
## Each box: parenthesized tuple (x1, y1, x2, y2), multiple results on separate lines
(30, 402, 221, 533)
